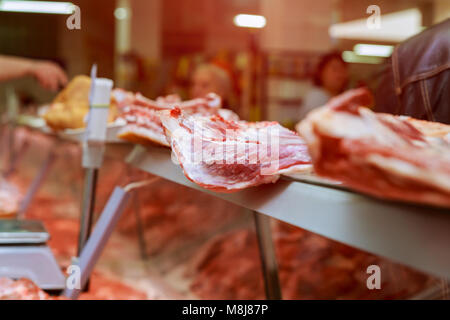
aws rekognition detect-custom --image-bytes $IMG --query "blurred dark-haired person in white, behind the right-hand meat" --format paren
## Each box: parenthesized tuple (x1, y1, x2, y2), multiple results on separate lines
(299, 52, 349, 119)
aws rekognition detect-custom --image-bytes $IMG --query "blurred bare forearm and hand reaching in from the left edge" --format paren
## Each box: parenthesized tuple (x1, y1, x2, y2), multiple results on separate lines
(0, 56, 67, 91)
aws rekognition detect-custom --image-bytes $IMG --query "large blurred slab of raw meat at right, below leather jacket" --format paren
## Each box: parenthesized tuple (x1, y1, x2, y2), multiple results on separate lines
(297, 89, 450, 207)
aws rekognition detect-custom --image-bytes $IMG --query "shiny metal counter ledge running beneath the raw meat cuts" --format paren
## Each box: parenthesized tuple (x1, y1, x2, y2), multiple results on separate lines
(126, 146, 450, 278)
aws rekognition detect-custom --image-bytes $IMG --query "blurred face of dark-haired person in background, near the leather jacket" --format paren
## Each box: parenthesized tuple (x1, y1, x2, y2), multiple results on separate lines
(322, 59, 349, 95)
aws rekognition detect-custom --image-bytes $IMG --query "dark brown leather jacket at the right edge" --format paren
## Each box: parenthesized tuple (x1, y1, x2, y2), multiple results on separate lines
(375, 19, 450, 124)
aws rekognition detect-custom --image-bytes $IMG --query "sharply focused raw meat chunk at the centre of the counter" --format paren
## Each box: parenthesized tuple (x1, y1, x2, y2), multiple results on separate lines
(161, 109, 311, 192)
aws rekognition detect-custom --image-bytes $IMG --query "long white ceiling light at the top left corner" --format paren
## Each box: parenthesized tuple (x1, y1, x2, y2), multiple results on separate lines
(0, 0, 74, 14)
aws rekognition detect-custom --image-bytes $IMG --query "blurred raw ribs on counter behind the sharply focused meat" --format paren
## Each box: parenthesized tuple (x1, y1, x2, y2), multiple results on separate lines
(114, 89, 238, 146)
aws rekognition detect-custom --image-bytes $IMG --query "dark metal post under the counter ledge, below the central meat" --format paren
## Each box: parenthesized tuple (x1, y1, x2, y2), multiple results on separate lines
(253, 211, 282, 300)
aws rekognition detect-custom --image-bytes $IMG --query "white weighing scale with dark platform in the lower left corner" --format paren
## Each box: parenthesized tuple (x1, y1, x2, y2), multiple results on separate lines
(0, 220, 65, 291)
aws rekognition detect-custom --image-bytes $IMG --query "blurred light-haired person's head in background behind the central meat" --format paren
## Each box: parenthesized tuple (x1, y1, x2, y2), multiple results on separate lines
(190, 64, 232, 107)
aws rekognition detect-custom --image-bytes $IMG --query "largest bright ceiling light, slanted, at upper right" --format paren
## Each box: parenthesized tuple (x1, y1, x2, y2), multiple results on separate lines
(329, 9, 423, 42)
